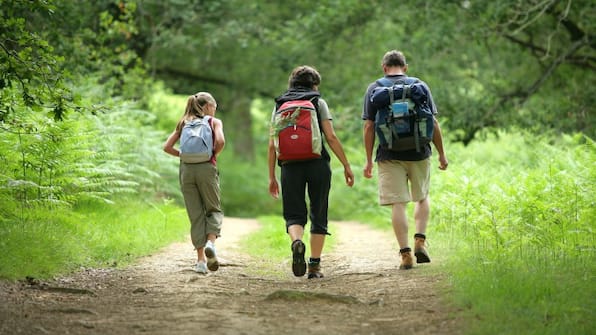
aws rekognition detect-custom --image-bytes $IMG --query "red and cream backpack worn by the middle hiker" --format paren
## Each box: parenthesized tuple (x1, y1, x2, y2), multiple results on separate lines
(271, 98, 323, 161)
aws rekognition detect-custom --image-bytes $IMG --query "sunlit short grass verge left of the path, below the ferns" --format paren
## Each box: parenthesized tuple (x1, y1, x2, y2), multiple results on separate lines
(0, 199, 188, 280)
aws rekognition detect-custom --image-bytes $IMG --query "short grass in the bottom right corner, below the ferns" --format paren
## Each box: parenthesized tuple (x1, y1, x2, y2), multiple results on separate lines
(446, 243, 596, 335)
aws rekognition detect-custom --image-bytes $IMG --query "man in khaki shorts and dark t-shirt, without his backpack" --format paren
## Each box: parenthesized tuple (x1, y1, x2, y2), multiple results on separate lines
(362, 50, 448, 269)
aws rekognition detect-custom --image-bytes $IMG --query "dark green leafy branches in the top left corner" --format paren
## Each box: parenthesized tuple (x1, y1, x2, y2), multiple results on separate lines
(0, 1, 75, 121)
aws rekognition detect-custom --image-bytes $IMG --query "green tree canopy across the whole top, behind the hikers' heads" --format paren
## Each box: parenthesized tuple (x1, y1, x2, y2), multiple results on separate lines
(0, 0, 596, 158)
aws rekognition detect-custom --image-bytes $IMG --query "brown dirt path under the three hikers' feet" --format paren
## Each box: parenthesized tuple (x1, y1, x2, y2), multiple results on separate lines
(0, 218, 460, 335)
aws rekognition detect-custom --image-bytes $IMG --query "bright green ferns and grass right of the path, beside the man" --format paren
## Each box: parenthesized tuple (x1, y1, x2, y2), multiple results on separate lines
(429, 134, 596, 335)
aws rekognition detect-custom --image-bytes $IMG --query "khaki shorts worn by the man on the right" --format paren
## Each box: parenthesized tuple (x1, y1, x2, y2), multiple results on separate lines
(378, 158, 430, 205)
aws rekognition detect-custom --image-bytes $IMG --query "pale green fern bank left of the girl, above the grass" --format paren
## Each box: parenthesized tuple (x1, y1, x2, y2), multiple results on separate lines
(0, 106, 172, 219)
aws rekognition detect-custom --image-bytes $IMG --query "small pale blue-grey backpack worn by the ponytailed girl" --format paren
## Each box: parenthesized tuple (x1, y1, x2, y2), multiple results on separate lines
(180, 115, 213, 163)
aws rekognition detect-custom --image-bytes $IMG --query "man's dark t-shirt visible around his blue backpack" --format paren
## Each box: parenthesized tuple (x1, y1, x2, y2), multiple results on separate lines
(362, 74, 437, 162)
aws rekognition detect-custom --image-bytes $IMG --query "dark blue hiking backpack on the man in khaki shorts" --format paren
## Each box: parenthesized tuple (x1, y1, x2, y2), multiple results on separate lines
(370, 77, 434, 152)
